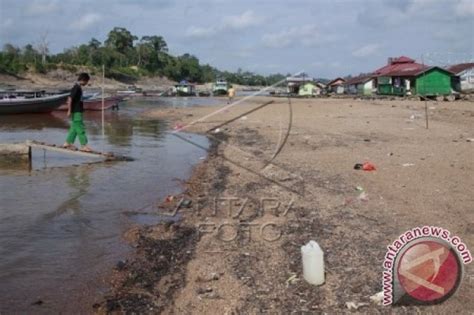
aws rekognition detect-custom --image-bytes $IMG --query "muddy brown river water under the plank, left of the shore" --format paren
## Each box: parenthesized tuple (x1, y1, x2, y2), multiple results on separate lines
(0, 99, 208, 313)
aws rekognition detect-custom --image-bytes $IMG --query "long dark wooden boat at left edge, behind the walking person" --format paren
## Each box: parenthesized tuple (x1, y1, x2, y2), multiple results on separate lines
(0, 91, 69, 115)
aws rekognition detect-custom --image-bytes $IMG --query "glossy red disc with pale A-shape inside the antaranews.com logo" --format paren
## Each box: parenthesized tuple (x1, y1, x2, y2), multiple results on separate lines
(397, 240, 462, 303)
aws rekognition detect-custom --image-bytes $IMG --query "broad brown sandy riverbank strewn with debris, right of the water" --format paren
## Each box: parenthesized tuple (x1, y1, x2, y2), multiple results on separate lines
(100, 97, 474, 314)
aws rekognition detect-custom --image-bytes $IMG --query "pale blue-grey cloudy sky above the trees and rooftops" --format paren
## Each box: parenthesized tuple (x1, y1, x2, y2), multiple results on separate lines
(0, 0, 474, 78)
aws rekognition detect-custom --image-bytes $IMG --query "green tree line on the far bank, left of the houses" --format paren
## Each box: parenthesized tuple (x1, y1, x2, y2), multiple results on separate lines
(0, 27, 285, 86)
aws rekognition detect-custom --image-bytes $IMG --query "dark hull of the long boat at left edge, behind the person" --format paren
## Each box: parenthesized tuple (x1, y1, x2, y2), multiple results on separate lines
(0, 93, 69, 115)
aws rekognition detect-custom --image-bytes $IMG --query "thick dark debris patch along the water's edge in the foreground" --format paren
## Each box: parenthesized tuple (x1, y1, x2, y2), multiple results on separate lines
(101, 225, 197, 314)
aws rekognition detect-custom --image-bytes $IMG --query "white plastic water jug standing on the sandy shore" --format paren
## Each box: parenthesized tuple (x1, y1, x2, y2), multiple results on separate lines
(301, 241, 324, 285)
